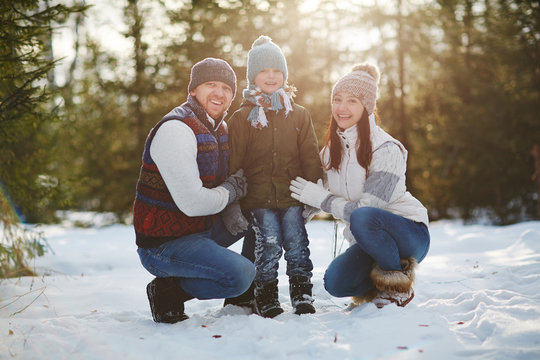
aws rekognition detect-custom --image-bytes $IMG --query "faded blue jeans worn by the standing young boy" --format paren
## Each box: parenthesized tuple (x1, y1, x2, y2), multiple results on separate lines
(250, 206, 313, 283)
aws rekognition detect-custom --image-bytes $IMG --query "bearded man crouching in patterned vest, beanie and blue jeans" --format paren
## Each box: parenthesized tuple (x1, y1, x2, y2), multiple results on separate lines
(133, 58, 255, 323)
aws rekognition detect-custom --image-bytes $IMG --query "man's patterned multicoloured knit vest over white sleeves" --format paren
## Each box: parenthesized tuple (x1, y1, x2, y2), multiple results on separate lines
(133, 103, 229, 248)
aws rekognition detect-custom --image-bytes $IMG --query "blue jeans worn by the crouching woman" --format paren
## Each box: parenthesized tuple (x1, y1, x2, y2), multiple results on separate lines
(324, 207, 430, 297)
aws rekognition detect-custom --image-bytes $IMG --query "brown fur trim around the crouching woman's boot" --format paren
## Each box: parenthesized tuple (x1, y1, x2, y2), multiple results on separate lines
(370, 257, 417, 293)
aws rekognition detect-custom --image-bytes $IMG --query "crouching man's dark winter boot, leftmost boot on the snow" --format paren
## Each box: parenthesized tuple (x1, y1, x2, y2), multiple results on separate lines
(146, 277, 193, 324)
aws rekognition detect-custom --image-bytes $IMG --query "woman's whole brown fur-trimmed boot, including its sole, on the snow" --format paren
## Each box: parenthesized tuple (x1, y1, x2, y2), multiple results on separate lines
(370, 257, 417, 308)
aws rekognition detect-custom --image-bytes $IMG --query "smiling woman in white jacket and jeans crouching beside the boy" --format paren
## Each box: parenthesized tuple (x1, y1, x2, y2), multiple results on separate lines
(290, 64, 430, 307)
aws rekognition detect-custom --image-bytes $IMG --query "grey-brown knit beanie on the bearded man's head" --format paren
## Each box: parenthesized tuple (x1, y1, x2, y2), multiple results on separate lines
(188, 58, 236, 98)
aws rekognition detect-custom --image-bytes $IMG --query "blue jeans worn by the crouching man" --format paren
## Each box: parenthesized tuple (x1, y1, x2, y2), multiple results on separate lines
(137, 219, 255, 299)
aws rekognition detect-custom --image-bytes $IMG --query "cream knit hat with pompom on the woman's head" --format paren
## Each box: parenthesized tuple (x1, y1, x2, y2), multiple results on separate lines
(332, 64, 381, 115)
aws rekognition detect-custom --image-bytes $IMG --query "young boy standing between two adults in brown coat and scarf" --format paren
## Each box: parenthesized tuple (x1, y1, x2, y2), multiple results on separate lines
(229, 36, 322, 318)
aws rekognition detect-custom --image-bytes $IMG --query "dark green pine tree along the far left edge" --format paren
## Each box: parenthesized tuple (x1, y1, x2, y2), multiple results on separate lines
(0, 0, 84, 277)
